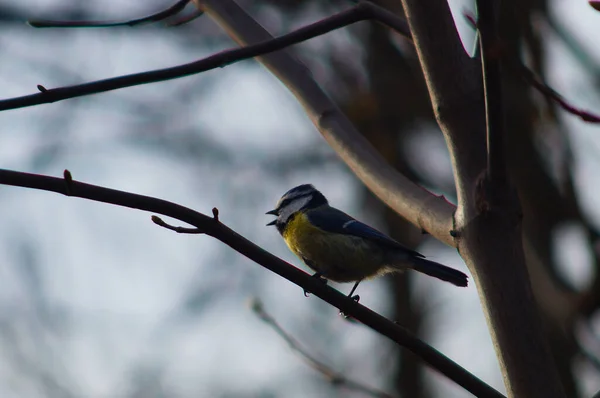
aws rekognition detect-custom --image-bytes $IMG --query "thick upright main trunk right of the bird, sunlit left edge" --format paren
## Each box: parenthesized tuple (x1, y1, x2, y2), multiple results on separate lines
(402, 0, 564, 398)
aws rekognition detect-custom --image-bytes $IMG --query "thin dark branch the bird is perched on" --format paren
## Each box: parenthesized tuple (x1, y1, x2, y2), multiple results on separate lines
(0, 169, 503, 398)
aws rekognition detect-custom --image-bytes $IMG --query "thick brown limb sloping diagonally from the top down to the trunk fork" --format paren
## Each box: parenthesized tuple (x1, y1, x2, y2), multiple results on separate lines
(195, 0, 455, 246)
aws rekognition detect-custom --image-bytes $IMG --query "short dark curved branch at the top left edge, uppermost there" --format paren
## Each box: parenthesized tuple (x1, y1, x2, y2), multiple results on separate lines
(27, 0, 191, 28)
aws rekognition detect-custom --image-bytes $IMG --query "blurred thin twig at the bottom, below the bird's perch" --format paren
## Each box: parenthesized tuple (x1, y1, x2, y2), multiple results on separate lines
(251, 299, 392, 398)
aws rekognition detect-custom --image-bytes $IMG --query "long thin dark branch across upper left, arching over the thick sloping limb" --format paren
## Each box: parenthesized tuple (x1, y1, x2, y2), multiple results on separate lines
(0, 3, 409, 111)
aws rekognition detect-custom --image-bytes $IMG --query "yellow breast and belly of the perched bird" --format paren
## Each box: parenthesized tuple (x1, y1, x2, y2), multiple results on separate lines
(283, 212, 384, 282)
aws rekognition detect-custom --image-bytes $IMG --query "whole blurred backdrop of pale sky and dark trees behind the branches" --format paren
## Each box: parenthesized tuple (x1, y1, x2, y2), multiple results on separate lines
(0, 0, 600, 398)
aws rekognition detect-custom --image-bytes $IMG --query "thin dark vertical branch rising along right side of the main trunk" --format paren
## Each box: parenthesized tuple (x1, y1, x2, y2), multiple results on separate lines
(476, 0, 508, 197)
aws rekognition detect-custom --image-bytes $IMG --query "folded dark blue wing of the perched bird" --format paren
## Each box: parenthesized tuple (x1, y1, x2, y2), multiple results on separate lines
(306, 207, 425, 257)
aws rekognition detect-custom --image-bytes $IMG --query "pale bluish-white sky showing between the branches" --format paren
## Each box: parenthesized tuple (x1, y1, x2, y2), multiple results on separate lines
(0, 0, 600, 398)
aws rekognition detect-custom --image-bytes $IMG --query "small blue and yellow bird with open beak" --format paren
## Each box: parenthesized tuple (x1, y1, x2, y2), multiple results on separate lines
(266, 184, 467, 301)
